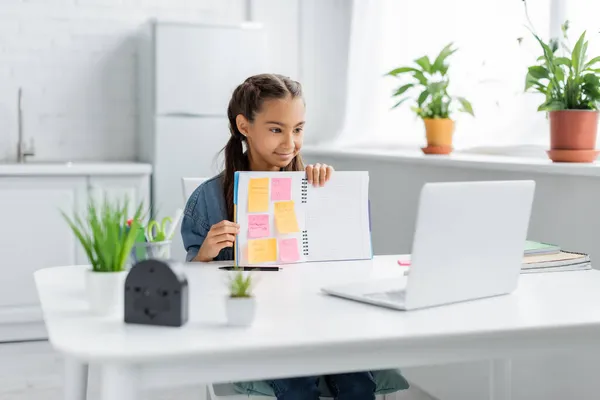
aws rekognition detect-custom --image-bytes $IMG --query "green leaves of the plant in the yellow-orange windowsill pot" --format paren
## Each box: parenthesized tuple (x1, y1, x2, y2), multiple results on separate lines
(386, 43, 474, 119)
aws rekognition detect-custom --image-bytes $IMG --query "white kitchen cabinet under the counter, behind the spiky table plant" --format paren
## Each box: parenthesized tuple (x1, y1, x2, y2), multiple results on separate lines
(0, 170, 150, 342)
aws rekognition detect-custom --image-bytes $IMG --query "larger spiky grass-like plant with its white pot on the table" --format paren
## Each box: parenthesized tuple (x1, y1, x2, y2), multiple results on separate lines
(62, 198, 142, 315)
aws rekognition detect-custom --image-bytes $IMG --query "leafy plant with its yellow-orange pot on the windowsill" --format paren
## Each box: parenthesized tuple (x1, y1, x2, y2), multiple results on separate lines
(386, 43, 474, 154)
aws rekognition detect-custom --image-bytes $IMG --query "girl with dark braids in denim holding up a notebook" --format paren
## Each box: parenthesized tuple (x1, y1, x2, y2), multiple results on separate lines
(181, 74, 375, 400)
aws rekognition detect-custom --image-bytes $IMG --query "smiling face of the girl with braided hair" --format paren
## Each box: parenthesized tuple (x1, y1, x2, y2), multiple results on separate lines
(236, 96, 305, 171)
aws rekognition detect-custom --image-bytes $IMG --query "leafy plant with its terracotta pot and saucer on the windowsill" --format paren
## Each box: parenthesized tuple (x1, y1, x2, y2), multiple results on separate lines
(525, 21, 600, 162)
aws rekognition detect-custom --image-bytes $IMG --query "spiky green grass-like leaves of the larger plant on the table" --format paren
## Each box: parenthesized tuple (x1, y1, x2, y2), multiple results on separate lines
(62, 198, 142, 272)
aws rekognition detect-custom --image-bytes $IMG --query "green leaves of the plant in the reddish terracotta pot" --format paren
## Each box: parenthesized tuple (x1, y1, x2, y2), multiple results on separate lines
(525, 21, 600, 111)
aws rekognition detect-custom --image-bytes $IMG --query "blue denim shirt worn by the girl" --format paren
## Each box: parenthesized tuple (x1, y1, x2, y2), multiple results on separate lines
(181, 174, 233, 262)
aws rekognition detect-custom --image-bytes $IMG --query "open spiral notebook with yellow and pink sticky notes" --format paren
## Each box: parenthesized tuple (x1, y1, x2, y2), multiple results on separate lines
(234, 171, 372, 266)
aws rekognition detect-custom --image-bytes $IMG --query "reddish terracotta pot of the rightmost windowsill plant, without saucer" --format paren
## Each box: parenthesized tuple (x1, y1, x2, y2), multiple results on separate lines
(550, 110, 598, 150)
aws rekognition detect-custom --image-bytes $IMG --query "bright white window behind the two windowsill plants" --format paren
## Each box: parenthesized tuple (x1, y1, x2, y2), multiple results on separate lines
(338, 0, 576, 152)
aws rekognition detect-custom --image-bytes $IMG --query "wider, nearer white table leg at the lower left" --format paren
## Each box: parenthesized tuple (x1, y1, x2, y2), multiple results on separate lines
(100, 364, 139, 400)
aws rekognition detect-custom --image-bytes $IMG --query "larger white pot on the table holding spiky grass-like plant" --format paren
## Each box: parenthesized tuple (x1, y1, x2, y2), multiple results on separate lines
(85, 270, 128, 316)
